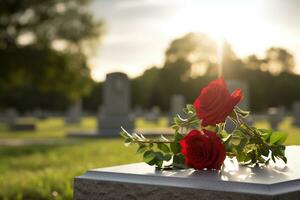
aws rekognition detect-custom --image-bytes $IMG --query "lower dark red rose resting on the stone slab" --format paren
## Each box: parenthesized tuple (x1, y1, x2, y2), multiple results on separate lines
(180, 130, 226, 170)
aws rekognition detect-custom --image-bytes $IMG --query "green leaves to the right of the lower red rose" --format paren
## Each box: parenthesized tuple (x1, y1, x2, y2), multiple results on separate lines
(223, 107, 287, 165)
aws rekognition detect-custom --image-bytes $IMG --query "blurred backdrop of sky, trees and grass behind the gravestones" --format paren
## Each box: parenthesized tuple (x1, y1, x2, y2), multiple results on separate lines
(0, 0, 300, 199)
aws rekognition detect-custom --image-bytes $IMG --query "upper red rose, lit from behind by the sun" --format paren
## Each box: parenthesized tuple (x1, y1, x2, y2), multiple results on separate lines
(194, 78, 243, 126)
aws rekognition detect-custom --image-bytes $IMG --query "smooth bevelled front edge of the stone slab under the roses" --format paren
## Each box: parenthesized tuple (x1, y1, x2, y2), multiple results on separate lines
(75, 168, 300, 196)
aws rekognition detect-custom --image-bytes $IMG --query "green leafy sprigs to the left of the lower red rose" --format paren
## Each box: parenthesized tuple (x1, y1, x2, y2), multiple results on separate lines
(120, 105, 199, 169)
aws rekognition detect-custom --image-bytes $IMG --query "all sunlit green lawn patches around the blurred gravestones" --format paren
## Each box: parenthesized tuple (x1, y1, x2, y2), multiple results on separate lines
(0, 118, 300, 200)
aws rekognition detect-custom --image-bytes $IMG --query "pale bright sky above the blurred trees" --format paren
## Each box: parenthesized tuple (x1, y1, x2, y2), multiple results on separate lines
(89, 0, 300, 81)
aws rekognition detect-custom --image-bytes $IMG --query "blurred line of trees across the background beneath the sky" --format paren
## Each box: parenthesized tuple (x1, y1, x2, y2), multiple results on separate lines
(0, 0, 300, 112)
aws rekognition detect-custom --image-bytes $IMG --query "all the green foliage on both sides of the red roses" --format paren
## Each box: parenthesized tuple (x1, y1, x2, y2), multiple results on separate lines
(120, 105, 287, 169)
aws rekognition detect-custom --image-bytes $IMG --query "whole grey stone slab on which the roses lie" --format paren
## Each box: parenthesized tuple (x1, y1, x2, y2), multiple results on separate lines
(74, 146, 300, 200)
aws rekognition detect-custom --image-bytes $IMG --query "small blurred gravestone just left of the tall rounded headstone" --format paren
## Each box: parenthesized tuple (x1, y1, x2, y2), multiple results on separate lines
(65, 99, 82, 124)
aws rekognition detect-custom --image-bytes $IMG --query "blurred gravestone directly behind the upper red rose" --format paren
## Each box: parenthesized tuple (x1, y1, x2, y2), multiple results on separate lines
(225, 80, 253, 133)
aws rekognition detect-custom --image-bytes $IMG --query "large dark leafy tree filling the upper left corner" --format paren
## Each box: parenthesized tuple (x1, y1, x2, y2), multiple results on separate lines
(0, 0, 102, 109)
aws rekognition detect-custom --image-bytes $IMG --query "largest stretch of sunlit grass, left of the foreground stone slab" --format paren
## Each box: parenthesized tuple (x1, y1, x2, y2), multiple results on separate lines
(0, 139, 140, 199)
